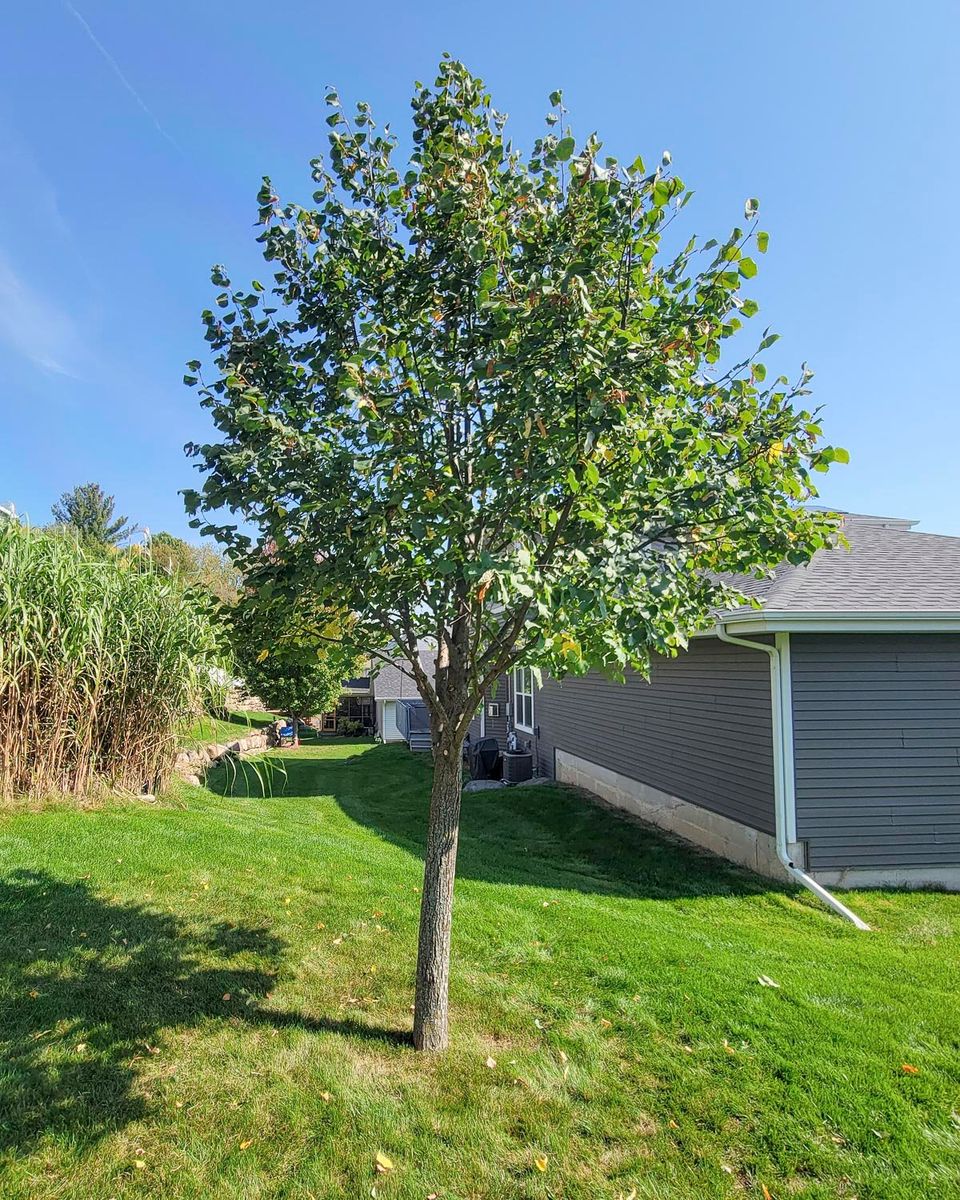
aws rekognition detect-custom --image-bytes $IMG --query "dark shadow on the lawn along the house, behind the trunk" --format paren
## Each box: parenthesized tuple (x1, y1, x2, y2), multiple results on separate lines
(236, 744, 794, 900)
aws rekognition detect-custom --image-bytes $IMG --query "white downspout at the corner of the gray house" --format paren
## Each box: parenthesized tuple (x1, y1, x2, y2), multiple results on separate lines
(716, 624, 870, 930)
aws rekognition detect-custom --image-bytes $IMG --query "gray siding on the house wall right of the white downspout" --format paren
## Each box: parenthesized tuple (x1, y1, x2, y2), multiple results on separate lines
(791, 634, 960, 869)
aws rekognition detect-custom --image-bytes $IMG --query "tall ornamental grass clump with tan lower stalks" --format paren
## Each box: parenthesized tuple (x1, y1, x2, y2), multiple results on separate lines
(0, 522, 222, 799)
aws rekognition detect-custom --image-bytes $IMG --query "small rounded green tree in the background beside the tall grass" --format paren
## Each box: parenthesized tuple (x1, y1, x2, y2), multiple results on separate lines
(230, 592, 356, 745)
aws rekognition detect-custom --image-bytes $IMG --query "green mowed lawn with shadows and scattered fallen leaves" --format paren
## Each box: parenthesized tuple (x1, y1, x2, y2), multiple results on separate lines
(0, 740, 960, 1200)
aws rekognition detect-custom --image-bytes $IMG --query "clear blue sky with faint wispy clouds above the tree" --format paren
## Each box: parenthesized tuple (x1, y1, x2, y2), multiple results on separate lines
(0, 0, 960, 534)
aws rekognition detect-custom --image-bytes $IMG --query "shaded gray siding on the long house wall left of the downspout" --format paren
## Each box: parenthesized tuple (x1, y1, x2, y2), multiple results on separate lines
(521, 637, 774, 833)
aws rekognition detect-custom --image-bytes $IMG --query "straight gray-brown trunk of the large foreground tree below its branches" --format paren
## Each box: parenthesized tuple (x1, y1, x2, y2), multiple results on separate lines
(413, 738, 463, 1050)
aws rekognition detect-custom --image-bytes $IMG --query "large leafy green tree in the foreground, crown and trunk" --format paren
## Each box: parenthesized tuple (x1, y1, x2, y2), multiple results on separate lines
(186, 59, 845, 1049)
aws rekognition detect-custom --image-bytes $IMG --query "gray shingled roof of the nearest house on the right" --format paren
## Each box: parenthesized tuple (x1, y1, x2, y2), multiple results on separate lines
(730, 512, 960, 617)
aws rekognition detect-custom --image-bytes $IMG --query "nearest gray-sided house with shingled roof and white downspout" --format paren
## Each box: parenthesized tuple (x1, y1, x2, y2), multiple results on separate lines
(499, 514, 960, 888)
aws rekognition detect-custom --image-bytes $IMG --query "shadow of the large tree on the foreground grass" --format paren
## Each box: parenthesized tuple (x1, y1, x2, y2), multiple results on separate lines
(0, 871, 403, 1153)
